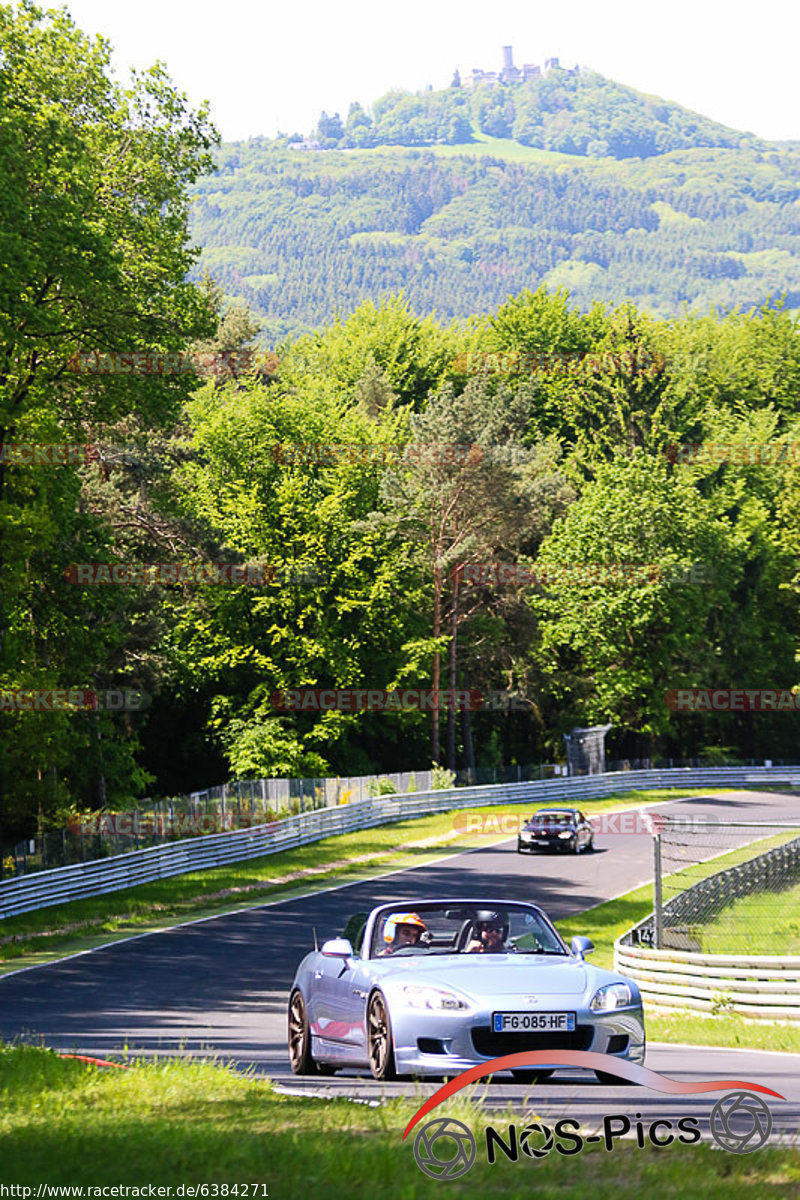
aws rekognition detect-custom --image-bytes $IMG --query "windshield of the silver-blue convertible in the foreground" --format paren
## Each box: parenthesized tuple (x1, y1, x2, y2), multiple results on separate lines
(371, 901, 567, 958)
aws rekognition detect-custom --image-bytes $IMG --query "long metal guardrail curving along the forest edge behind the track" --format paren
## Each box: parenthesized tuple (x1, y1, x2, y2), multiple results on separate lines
(0, 767, 800, 919)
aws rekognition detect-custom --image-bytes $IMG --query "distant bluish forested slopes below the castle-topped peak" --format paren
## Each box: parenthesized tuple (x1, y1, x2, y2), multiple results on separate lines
(192, 140, 800, 343)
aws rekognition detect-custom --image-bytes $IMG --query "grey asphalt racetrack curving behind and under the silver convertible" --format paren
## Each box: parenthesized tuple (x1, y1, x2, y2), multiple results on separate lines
(0, 792, 800, 1138)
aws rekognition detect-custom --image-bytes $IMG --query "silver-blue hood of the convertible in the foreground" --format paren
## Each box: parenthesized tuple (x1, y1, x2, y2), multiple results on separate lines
(376, 954, 588, 1000)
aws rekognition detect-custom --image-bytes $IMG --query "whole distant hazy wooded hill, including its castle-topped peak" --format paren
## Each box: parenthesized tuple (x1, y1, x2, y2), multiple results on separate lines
(192, 72, 800, 342)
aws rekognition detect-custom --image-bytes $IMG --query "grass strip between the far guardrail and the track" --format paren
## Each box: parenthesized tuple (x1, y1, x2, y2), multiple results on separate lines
(0, 788, 730, 972)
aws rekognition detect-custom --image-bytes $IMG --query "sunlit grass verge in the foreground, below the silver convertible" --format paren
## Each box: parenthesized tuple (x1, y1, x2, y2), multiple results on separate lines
(0, 1046, 800, 1200)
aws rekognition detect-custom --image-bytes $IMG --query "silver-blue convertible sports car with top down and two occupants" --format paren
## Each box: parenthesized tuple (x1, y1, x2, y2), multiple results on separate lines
(289, 900, 644, 1082)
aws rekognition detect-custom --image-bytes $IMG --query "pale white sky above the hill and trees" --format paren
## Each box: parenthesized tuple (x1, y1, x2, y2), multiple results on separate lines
(57, 0, 800, 140)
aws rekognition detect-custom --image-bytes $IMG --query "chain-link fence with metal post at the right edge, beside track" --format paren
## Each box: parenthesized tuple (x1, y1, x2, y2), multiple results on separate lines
(652, 816, 800, 955)
